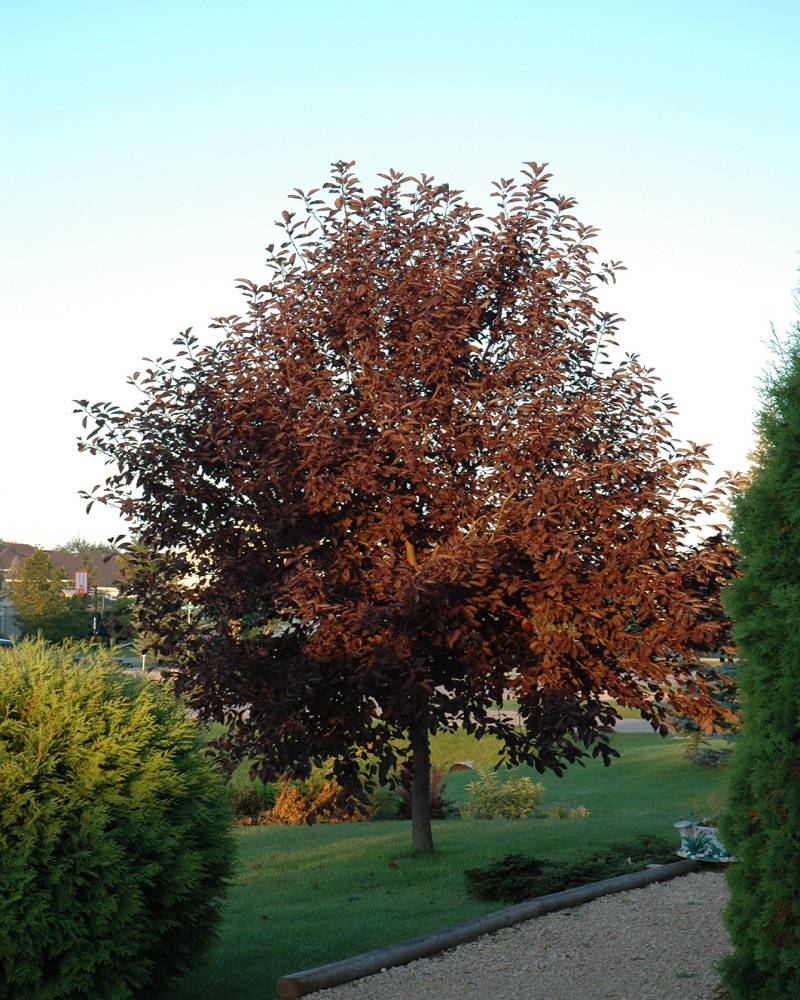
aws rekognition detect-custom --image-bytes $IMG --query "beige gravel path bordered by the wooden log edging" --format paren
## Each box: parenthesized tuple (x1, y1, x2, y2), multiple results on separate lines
(309, 872, 729, 1000)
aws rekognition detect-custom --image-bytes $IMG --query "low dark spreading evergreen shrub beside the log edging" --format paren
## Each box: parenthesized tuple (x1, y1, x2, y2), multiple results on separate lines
(464, 835, 675, 903)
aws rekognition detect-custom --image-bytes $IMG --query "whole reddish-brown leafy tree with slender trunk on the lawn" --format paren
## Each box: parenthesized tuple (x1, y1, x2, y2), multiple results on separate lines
(79, 163, 728, 851)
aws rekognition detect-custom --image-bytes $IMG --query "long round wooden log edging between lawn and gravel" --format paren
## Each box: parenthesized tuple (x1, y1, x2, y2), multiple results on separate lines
(275, 859, 703, 998)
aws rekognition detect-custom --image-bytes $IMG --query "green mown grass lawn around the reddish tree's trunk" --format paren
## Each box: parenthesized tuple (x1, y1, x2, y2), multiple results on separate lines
(167, 732, 723, 1000)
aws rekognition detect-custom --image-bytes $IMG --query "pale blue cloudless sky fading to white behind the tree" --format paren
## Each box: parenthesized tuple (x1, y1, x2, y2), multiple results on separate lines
(0, 0, 800, 546)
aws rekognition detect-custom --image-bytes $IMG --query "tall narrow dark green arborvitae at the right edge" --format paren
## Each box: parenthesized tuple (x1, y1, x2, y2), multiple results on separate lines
(722, 316, 800, 1000)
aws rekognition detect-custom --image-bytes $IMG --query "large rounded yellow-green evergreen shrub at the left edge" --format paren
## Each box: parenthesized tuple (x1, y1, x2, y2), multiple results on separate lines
(0, 641, 233, 1000)
